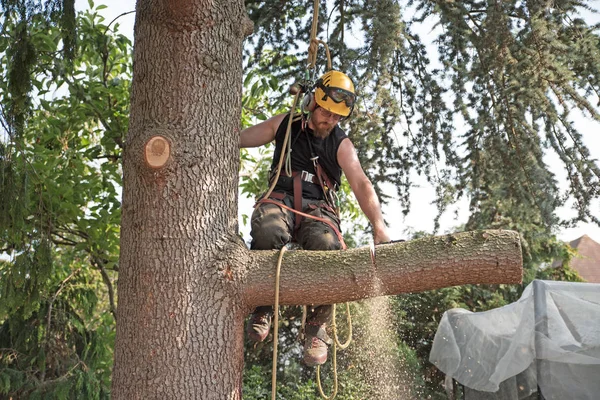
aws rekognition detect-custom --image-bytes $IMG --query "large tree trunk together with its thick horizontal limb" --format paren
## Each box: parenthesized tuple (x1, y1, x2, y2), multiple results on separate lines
(113, 0, 520, 400)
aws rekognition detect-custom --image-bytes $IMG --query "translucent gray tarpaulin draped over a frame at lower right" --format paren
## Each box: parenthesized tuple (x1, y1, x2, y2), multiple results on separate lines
(429, 281, 600, 400)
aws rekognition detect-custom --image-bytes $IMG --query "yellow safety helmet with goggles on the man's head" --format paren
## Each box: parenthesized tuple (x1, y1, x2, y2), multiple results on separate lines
(315, 71, 356, 117)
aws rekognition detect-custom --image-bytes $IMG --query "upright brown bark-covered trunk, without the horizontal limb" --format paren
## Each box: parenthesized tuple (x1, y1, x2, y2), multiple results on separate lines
(113, 0, 247, 400)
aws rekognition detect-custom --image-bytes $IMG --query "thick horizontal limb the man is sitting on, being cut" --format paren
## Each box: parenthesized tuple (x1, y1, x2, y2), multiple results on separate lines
(243, 230, 523, 307)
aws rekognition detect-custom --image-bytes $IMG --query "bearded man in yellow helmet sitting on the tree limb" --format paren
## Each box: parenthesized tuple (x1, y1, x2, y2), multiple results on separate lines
(240, 71, 389, 366)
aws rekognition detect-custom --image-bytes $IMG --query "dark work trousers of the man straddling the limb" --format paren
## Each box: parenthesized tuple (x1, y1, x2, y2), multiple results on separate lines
(250, 195, 342, 324)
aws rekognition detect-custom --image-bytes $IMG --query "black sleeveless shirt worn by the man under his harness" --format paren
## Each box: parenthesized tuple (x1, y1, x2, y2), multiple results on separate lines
(271, 114, 348, 199)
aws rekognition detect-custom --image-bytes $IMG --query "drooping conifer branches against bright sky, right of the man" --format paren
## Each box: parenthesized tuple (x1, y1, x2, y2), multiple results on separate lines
(246, 0, 600, 241)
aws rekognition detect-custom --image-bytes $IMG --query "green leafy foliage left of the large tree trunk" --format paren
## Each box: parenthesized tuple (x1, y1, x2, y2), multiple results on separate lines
(0, 6, 131, 399)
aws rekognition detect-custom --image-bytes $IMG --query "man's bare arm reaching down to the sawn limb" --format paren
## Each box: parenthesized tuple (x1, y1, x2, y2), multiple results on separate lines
(337, 139, 390, 244)
